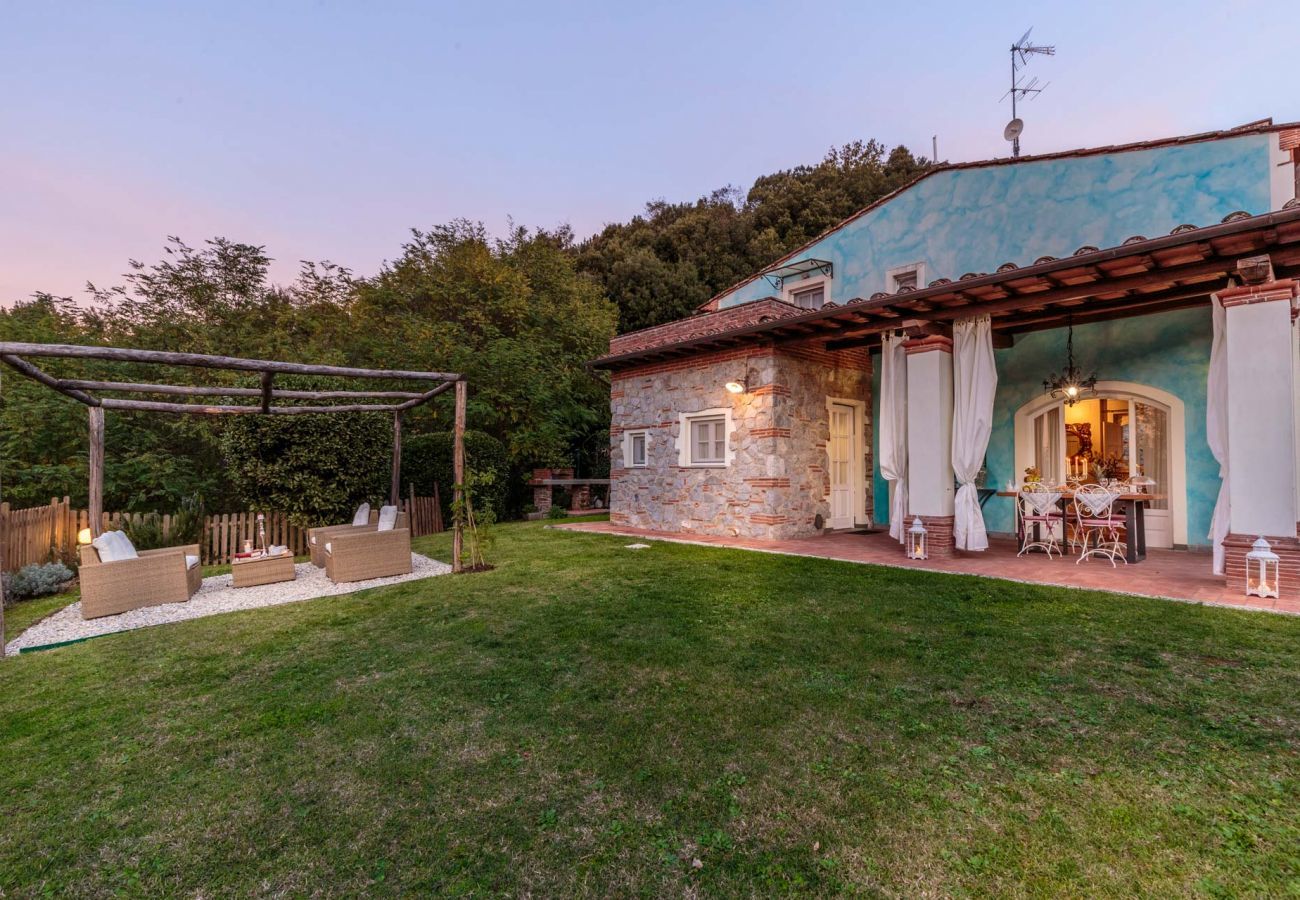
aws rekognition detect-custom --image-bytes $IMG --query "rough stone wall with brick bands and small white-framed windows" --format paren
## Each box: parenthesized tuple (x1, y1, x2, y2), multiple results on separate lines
(610, 345, 871, 540)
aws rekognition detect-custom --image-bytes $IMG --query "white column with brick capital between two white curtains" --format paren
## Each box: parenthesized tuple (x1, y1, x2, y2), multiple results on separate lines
(904, 334, 956, 558)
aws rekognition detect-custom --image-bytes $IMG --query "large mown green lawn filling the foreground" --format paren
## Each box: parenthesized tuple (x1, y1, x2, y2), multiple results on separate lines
(0, 523, 1300, 897)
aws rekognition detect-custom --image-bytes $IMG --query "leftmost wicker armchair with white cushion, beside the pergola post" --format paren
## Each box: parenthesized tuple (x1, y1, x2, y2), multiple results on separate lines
(81, 544, 203, 619)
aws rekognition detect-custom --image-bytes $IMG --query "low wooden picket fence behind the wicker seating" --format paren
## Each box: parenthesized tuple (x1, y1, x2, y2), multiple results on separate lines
(0, 489, 443, 571)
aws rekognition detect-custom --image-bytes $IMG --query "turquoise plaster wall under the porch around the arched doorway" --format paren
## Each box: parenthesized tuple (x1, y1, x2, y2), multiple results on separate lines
(872, 308, 1219, 545)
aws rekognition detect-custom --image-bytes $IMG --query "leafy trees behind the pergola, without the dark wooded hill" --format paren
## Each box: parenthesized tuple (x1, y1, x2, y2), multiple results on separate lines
(0, 222, 615, 522)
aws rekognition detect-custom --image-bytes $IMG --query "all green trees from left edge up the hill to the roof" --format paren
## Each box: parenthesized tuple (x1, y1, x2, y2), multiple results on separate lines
(0, 135, 927, 518)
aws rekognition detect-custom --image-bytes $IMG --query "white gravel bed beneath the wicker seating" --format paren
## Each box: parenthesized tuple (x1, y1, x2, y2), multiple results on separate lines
(7, 553, 451, 653)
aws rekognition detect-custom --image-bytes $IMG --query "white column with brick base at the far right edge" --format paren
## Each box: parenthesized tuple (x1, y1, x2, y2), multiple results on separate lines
(1218, 278, 1300, 597)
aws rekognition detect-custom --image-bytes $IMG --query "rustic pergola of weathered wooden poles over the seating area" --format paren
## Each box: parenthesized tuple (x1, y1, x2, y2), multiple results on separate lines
(0, 342, 465, 571)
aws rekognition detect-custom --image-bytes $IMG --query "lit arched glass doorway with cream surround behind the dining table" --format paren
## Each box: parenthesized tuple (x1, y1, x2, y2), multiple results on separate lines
(1015, 381, 1187, 548)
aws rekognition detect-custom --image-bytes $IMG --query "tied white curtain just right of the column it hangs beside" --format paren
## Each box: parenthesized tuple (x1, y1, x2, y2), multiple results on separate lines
(953, 316, 997, 550)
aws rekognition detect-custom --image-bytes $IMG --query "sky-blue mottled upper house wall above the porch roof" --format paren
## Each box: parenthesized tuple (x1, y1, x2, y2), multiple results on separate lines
(720, 134, 1269, 307)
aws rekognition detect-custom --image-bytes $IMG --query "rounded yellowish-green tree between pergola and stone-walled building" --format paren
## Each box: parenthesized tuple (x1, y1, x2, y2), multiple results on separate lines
(355, 221, 615, 473)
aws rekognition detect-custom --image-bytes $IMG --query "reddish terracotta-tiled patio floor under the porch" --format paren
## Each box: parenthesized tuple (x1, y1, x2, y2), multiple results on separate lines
(554, 522, 1300, 615)
